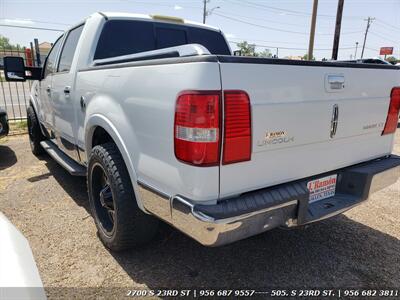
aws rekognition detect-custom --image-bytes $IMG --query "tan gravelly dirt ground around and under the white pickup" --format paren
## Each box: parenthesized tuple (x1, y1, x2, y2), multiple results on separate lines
(0, 130, 400, 296)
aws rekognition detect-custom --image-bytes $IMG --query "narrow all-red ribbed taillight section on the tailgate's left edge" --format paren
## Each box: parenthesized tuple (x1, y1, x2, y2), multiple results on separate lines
(222, 91, 251, 165)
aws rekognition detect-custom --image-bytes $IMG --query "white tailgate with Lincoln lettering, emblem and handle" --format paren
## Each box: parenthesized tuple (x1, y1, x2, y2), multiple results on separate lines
(220, 59, 400, 198)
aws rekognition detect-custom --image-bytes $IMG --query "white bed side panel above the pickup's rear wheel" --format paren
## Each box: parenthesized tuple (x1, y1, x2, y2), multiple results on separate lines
(77, 62, 221, 201)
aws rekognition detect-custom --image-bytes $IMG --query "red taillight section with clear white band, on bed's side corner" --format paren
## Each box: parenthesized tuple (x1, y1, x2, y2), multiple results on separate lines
(174, 91, 221, 166)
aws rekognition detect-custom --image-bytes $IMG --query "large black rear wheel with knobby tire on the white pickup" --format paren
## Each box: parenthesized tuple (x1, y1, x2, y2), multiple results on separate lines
(87, 143, 159, 251)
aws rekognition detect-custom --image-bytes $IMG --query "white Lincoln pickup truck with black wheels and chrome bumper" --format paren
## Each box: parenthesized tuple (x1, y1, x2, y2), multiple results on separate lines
(5, 13, 400, 250)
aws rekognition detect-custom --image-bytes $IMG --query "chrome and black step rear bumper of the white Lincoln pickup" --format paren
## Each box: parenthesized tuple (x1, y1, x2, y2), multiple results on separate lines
(139, 155, 400, 246)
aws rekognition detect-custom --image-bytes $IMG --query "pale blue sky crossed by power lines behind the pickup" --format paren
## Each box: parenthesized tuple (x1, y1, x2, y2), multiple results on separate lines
(0, 0, 400, 59)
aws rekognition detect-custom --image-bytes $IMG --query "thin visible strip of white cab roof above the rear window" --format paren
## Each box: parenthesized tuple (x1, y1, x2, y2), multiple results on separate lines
(99, 12, 220, 31)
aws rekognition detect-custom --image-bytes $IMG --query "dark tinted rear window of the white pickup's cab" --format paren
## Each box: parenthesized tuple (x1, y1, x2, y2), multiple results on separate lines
(94, 20, 231, 59)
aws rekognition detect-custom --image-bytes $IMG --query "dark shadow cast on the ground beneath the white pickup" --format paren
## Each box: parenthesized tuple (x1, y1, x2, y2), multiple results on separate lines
(41, 152, 400, 289)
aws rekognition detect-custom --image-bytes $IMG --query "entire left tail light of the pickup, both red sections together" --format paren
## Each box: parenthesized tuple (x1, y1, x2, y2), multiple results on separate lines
(174, 91, 251, 167)
